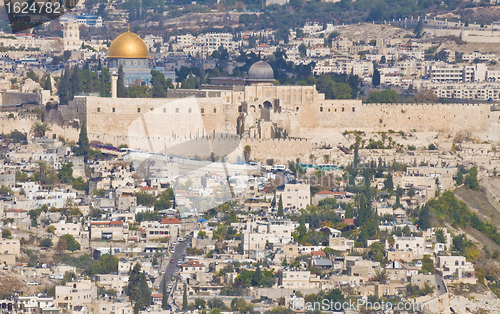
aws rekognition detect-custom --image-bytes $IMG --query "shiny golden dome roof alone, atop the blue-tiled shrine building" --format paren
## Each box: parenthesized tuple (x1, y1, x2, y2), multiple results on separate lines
(108, 32, 149, 59)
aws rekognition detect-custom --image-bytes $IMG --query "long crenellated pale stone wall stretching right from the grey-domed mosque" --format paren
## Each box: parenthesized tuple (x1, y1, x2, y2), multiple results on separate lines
(310, 101, 500, 141)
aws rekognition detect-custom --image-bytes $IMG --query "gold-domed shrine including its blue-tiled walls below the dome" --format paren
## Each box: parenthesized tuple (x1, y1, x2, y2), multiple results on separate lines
(108, 31, 151, 86)
